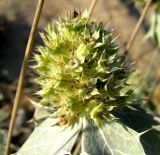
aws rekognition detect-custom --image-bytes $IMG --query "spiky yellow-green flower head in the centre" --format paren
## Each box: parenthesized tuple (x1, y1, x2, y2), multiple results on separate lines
(34, 12, 132, 125)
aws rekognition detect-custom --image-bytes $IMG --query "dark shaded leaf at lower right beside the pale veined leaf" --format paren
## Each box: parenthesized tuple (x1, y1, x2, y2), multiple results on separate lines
(114, 103, 160, 155)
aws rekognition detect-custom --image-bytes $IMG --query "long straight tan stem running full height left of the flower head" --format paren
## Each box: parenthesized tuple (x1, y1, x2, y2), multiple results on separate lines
(5, 0, 44, 155)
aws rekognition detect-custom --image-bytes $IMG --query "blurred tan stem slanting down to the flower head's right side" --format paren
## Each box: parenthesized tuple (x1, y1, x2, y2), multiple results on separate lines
(126, 0, 152, 52)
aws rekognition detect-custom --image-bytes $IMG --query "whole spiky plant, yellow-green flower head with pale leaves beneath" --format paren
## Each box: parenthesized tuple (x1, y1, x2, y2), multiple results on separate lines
(18, 12, 160, 155)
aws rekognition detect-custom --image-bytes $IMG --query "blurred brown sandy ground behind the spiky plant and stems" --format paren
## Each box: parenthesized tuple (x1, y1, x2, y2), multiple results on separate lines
(0, 0, 160, 154)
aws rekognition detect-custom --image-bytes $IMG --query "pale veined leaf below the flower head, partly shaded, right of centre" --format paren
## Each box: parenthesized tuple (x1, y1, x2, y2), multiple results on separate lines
(82, 118, 145, 155)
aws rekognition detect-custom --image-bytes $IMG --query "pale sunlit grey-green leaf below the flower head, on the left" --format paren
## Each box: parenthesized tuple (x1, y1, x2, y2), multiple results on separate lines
(16, 118, 81, 155)
